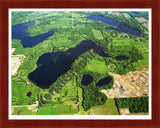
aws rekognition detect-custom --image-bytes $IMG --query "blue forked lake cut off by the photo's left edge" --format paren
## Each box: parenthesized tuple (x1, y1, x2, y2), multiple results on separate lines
(12, 22, 55, 48)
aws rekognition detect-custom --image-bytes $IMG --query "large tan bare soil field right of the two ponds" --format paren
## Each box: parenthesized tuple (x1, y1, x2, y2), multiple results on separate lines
(101, 71, 149, 98)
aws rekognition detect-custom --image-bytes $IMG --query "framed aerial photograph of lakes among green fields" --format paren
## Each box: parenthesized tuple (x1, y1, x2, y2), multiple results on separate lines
(9, 9, 151, 116)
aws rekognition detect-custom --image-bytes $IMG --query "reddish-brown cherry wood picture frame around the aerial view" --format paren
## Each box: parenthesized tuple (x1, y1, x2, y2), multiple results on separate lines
(0, 0, 160, 128)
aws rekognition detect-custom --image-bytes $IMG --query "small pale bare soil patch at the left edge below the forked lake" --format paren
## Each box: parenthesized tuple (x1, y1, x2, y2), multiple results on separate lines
(11, 48, 24, 75)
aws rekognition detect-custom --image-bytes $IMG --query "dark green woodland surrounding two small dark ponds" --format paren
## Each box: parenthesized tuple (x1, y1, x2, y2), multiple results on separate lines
(77, 70, 113, 111)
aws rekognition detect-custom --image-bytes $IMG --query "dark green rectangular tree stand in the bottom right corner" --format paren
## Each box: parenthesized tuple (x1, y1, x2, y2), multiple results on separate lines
(115, 97, 149, 113)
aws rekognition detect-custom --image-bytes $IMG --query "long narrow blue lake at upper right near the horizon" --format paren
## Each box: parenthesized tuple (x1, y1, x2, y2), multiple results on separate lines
(87, 15, 141, 36)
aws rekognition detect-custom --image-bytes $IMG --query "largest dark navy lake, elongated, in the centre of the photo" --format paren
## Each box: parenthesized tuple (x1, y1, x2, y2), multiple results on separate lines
(28, 40, 109, 89)
